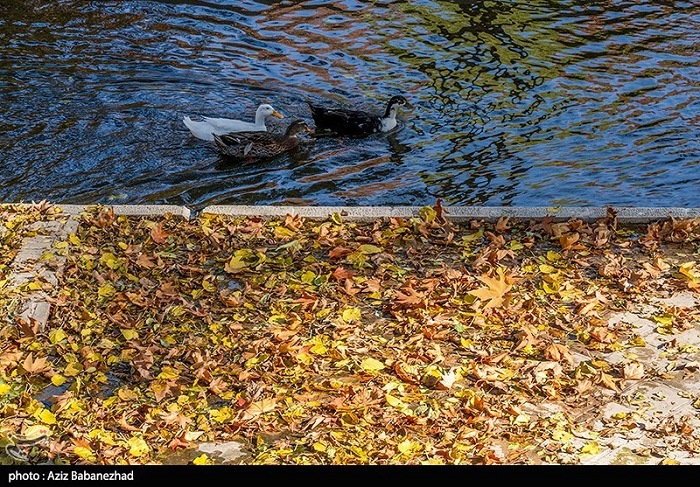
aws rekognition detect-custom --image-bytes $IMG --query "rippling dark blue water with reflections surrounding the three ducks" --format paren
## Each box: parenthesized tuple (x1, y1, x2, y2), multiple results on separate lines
(0, 0, 700, 210)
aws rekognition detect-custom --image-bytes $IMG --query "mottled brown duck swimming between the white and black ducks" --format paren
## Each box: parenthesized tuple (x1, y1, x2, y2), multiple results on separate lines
(214, 120, 311, 160)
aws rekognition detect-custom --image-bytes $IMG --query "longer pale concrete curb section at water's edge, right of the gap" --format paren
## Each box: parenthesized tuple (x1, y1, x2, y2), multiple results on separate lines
(202, 205, 700, 223)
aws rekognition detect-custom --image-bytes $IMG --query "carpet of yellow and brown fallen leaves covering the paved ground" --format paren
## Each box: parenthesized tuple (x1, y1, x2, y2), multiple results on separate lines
(0, 203, 700, 464)
